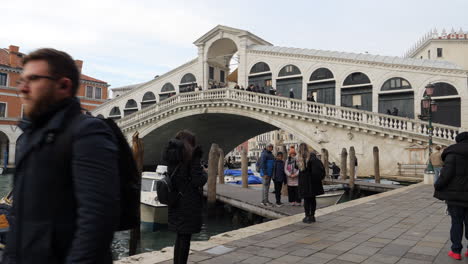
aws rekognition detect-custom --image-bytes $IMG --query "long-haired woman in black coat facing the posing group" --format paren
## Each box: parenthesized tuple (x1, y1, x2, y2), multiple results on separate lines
(297, 143, 325, 223)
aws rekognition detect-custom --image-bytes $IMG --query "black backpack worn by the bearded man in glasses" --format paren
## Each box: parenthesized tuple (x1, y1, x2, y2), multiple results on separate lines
(58, 114, 141, 231)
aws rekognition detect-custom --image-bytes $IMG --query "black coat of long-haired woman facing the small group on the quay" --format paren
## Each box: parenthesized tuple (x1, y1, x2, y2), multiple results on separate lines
(299, 153, 325, 198)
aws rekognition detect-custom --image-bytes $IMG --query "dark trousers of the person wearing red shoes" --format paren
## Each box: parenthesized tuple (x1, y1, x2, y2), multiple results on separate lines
(448, 205, 468, 254)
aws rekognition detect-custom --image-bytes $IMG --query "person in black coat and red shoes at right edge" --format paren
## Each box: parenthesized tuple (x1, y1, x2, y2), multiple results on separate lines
(434, 132, 468, 260)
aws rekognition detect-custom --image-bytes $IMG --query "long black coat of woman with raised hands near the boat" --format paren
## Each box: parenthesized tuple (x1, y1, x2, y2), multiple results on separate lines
(164, 139, 208, 234)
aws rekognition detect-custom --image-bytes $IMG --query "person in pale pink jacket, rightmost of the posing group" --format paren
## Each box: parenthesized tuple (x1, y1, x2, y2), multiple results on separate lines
(284, 146, 301, 206)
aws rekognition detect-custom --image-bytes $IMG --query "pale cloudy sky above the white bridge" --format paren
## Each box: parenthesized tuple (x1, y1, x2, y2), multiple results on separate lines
(0, 0, 468, 88)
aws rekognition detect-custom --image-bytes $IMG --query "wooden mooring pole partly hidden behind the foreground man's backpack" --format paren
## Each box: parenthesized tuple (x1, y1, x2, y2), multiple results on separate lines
(130, 131, 144, 256)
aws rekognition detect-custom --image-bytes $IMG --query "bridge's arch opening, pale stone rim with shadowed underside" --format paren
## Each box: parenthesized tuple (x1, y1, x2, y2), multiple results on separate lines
(134, 107, 322, 165)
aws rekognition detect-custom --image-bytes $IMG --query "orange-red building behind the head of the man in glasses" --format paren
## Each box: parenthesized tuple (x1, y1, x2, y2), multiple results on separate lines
(0, 45, 109, 167)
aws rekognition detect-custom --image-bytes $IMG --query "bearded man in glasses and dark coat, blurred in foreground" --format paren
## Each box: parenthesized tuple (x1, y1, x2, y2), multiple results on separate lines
(2, 49, 120, 264)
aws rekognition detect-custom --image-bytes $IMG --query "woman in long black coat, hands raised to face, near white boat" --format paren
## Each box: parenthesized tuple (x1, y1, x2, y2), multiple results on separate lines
(164, 130, 207, 264)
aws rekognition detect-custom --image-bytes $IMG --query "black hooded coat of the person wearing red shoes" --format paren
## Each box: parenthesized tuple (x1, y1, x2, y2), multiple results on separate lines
(434, 132, 468, 207)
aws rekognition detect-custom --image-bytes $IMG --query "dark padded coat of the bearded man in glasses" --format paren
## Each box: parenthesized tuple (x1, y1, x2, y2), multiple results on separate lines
(3, 98, 120, 264)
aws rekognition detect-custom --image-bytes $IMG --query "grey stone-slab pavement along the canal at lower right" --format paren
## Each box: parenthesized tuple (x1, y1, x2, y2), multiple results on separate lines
(168, 184, 468, 264)
